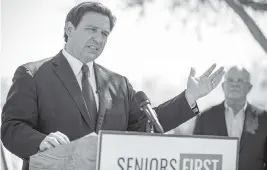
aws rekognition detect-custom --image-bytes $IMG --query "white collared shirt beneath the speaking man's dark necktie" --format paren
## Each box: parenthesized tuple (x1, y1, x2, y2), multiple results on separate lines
(62, 49, 99, 110)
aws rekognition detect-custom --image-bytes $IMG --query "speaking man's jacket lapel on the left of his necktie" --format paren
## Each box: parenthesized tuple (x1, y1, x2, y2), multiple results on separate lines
(53, 51, 94, 129)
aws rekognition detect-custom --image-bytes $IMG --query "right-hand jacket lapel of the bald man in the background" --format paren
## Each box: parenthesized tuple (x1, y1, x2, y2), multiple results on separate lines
(239, 103, 259, 153)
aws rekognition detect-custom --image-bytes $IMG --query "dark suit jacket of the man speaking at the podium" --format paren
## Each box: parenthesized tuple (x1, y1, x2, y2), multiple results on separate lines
(1, 52, 195, 169)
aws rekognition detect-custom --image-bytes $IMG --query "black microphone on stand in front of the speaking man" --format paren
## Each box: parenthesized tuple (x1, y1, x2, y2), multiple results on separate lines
(135, 91, 164, 133)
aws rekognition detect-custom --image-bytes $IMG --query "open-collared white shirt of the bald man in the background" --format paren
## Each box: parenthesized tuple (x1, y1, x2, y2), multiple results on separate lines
(224, 102, 247, 138)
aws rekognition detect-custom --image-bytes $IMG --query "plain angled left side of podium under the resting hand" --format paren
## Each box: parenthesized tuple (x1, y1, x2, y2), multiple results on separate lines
(29, 135, 98, 170)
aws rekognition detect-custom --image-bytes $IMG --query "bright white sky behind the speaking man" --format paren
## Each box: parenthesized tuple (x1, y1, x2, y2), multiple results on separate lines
(0, 0, 267, 107)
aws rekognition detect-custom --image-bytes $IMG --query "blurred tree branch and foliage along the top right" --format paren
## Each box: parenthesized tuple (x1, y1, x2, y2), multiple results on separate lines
(122, 0, 267, 54)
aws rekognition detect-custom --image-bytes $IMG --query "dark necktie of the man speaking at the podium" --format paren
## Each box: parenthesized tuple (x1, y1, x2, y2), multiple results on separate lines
(82, 64, 97, 130)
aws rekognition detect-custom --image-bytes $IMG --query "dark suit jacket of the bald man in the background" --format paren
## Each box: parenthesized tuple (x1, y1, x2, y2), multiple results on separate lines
(194, 102, 267, 170)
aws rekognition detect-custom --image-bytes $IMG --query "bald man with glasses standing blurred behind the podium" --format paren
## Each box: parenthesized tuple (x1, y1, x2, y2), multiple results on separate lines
(194, 66, 267, 170)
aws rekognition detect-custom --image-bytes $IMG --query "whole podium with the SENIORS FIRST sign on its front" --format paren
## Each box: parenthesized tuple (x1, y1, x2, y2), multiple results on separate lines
(30, 131, 239, 170)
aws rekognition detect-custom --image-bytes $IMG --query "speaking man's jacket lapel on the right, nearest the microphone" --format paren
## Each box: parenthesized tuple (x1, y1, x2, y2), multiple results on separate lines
(94, 63, 112, 133)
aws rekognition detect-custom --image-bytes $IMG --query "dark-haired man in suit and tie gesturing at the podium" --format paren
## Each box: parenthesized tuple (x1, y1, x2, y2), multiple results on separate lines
(1, 2, 224, 168)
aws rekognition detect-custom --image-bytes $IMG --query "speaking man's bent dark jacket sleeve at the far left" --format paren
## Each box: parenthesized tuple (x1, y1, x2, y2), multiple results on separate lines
(1, 66, 46, 159)
